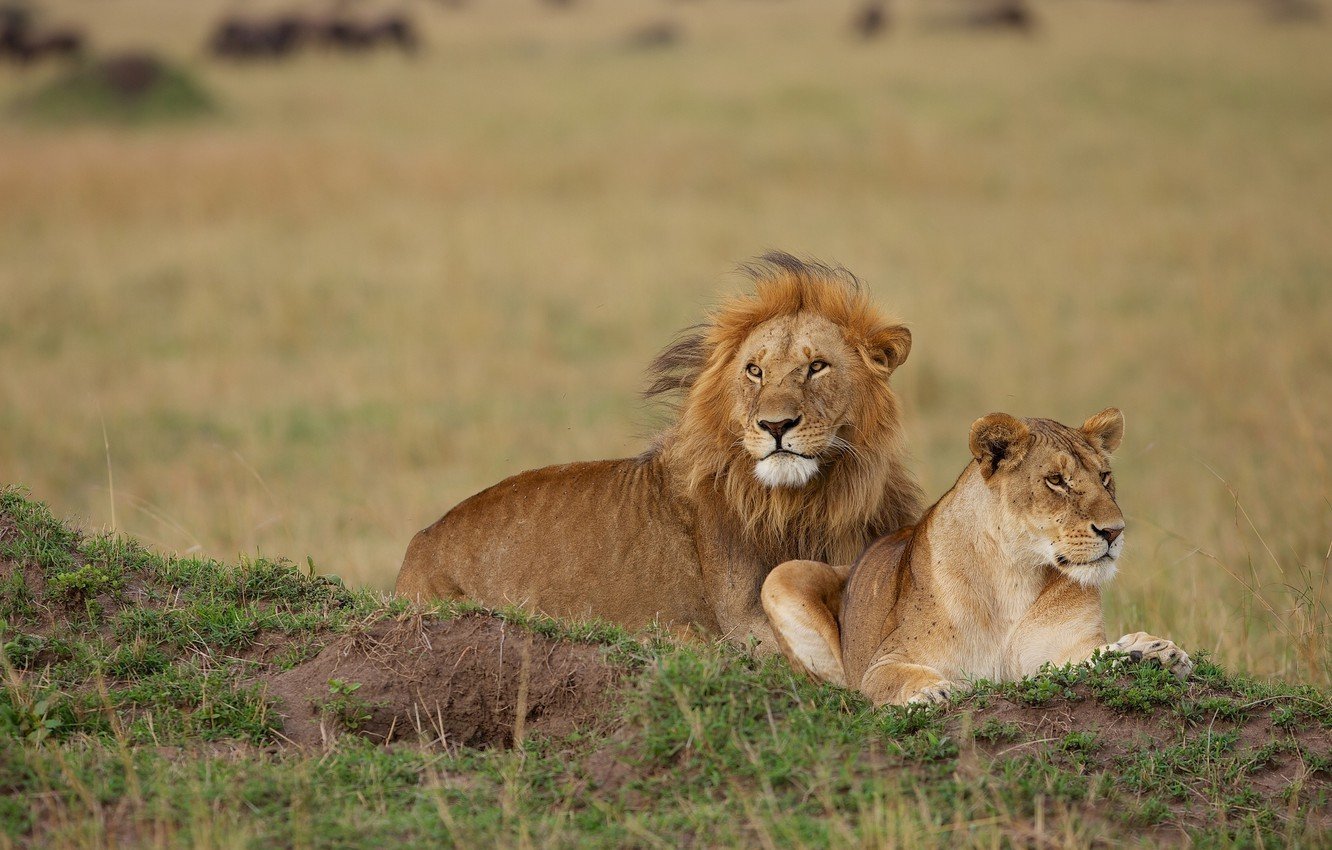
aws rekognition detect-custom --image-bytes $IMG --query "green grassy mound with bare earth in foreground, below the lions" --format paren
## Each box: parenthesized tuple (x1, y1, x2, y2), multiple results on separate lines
(0, 489, 1332, 849)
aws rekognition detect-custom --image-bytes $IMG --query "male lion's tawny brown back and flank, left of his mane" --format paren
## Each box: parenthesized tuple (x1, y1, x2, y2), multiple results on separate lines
(397, 458, 717, 630)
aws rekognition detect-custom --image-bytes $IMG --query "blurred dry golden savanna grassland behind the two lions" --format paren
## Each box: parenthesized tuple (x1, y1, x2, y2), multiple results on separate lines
(0, 0, 1332, 685)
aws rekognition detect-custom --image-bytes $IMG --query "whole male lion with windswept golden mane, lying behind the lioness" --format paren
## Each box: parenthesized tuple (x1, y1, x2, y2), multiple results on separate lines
(397, 253, 922, 651)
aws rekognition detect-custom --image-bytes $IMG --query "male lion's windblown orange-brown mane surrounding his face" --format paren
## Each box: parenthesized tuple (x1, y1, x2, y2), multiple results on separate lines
(645, 253, 923, 564)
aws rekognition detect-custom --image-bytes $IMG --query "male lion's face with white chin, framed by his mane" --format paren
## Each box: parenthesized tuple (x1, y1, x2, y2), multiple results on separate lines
(730, 313, 868, 488)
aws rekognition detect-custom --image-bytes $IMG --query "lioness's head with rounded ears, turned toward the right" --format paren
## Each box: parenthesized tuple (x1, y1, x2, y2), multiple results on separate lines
(971, 408, 1124, 585)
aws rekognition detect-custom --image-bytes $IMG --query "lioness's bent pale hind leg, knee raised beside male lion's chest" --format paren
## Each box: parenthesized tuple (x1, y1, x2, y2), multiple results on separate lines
(759, 561, 851, 686)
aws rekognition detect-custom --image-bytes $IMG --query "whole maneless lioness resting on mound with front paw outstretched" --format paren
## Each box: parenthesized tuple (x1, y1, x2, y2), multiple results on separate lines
(762, 408, 1193, 705)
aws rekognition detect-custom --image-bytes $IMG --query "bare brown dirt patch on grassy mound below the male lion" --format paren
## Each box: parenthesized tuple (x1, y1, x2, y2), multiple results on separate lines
(266, 616, 618, 746)
